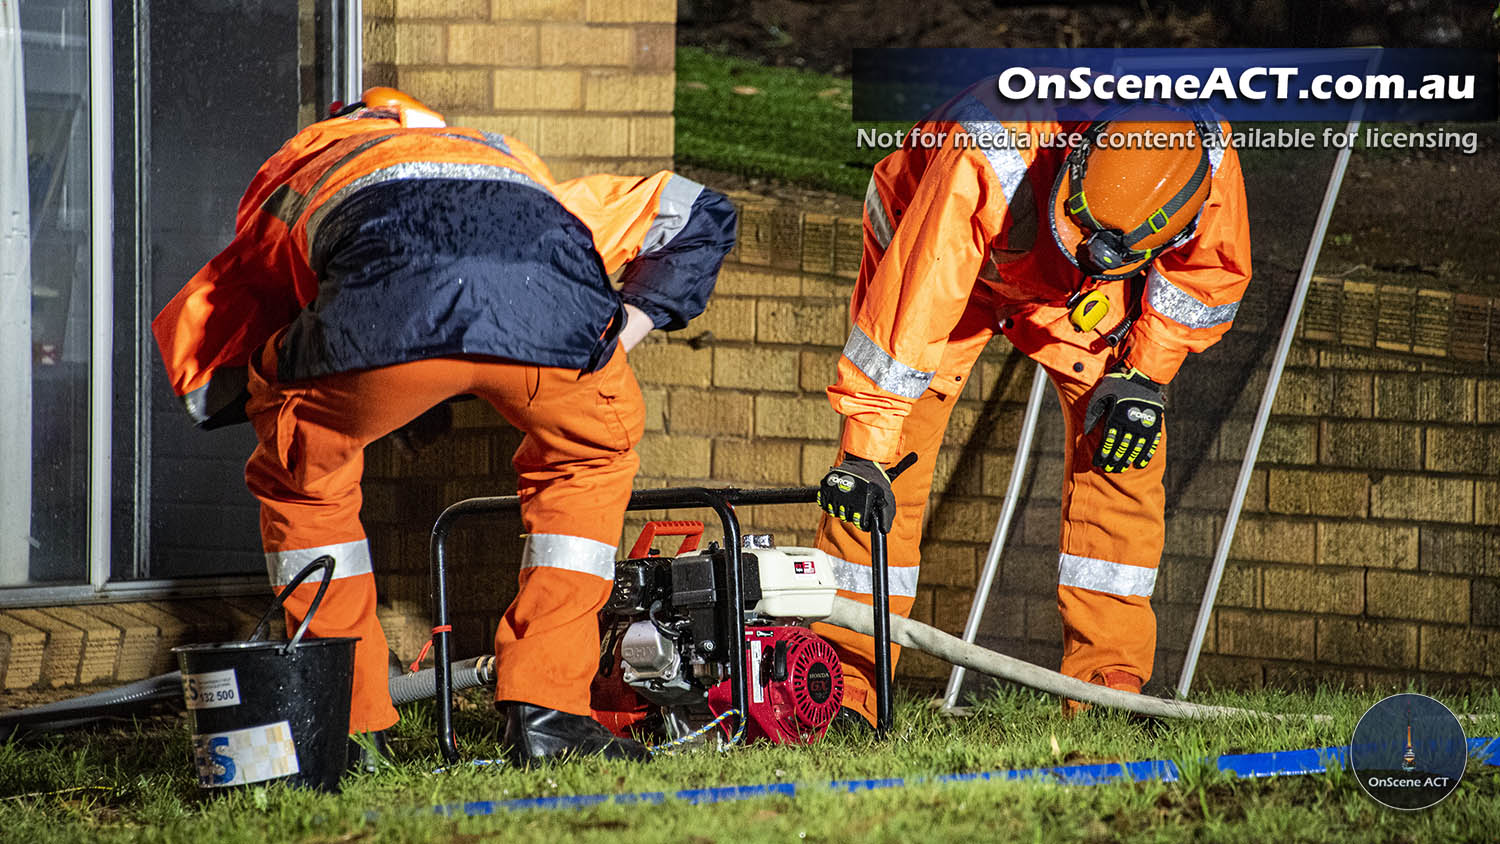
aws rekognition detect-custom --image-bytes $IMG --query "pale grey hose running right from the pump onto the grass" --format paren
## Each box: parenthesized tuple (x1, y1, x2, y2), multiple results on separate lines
(824, 598, 1332, 723)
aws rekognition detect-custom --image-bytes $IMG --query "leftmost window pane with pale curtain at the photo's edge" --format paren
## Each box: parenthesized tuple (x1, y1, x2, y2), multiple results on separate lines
(0, 0, 92, 586)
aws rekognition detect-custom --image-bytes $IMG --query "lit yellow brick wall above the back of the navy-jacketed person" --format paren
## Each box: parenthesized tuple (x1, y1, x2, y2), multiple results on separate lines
(365, 0, 677, 178)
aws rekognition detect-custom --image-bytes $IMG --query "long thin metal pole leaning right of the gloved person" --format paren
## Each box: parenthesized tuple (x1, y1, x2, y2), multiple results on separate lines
(1178, 111, 1361, 697)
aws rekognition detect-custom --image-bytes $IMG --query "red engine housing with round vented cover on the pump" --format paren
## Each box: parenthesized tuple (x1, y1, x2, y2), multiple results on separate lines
(708, 627, 843, 745)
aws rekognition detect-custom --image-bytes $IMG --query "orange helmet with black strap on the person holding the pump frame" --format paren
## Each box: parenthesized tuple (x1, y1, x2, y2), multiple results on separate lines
(1052, 112, 1220, 279)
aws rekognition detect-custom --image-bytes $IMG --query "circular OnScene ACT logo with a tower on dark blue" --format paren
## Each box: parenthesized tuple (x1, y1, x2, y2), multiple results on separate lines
(1349, 694, 1469, 811)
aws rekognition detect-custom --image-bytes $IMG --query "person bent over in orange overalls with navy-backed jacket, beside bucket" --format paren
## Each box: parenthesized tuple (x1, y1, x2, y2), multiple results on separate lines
(153, 88, 735, 763)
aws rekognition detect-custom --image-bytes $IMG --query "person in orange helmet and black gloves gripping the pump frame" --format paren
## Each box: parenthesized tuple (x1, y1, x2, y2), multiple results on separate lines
(816, 94, 1250, 721)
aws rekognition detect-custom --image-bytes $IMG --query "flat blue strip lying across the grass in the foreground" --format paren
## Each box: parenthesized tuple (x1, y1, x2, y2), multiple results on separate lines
(432, 738, 1500, 816)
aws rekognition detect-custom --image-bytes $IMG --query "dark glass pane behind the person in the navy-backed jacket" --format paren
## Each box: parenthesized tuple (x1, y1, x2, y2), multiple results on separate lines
(140, 0, 312, 579)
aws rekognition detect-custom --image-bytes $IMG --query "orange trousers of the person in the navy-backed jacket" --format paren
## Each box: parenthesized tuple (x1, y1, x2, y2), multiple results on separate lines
(245, 334, 645, 732)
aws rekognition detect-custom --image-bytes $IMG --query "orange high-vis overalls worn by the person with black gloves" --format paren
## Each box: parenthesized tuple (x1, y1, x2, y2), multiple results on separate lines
(818, 96, 1250, 718)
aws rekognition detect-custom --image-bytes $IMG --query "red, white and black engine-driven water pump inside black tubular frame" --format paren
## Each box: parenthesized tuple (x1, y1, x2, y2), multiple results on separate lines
(593, 522, 843, 744)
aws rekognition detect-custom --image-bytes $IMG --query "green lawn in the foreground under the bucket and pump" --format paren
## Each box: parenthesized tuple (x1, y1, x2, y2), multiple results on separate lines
(0, 691, 1500, 844)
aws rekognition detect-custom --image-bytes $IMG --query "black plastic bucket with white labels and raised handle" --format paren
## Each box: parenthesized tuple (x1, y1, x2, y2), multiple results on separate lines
(173, 556, 359, 792)
